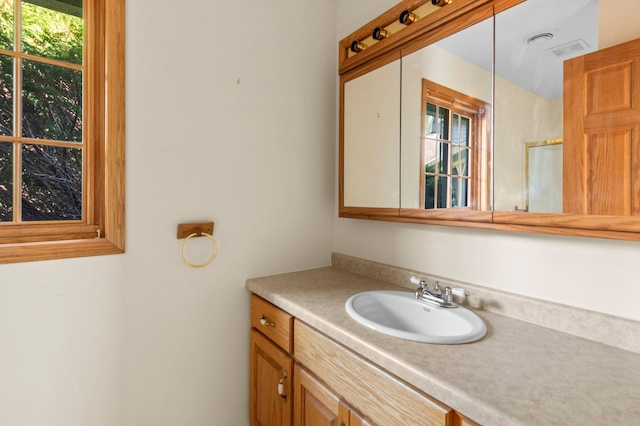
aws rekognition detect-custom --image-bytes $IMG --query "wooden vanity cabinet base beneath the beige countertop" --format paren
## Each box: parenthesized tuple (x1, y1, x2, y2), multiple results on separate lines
(250, 295, 476, 426)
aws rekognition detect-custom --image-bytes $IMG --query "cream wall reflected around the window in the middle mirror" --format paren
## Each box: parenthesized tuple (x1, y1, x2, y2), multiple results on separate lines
(400, 45, 492, 209)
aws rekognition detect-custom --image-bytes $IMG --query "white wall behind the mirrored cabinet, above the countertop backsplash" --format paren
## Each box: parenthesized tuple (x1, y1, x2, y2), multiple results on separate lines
(335, 0, 640, 320)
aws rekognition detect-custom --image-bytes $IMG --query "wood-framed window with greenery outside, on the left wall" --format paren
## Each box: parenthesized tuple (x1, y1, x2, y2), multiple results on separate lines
(0, 0, 124, 263)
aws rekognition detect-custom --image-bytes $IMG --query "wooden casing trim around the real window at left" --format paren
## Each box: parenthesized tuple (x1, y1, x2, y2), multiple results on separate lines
(0, 0, 125, 263)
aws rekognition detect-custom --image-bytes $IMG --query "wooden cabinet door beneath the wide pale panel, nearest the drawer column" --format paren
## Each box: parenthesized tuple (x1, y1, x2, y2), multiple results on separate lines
(293, 364, 350, 426)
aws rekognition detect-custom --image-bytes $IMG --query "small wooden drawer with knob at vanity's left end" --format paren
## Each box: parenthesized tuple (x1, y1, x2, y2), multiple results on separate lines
(251, 294, 293, 353)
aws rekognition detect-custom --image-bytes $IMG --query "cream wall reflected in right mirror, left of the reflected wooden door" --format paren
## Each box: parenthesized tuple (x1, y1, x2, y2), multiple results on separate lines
(494, 76, 562, 211)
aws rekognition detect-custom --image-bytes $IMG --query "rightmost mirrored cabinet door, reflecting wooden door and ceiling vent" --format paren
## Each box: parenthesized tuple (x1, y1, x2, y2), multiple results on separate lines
(494, 0, 640, 216)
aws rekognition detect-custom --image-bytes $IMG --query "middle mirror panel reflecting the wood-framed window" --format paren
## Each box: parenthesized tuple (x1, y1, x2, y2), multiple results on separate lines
(400, 18, 493, 212)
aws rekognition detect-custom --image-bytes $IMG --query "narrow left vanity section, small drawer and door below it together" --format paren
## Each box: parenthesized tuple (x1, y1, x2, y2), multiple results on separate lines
(249, 295, 293, 426)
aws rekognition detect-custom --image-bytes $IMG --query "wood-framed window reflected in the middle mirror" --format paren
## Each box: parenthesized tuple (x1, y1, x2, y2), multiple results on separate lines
(420, 80, 489, 210)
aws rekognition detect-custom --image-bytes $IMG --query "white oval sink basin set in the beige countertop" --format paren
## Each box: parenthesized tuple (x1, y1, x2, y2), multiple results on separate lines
(345, 291, 487, 344)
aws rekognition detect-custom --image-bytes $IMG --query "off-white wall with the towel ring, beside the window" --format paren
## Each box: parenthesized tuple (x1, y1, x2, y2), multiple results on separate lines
(0, 0, 337, 426)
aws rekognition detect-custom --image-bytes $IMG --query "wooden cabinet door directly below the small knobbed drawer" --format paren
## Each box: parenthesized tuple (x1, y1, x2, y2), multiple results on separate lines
(250, 329, 293, 426)
